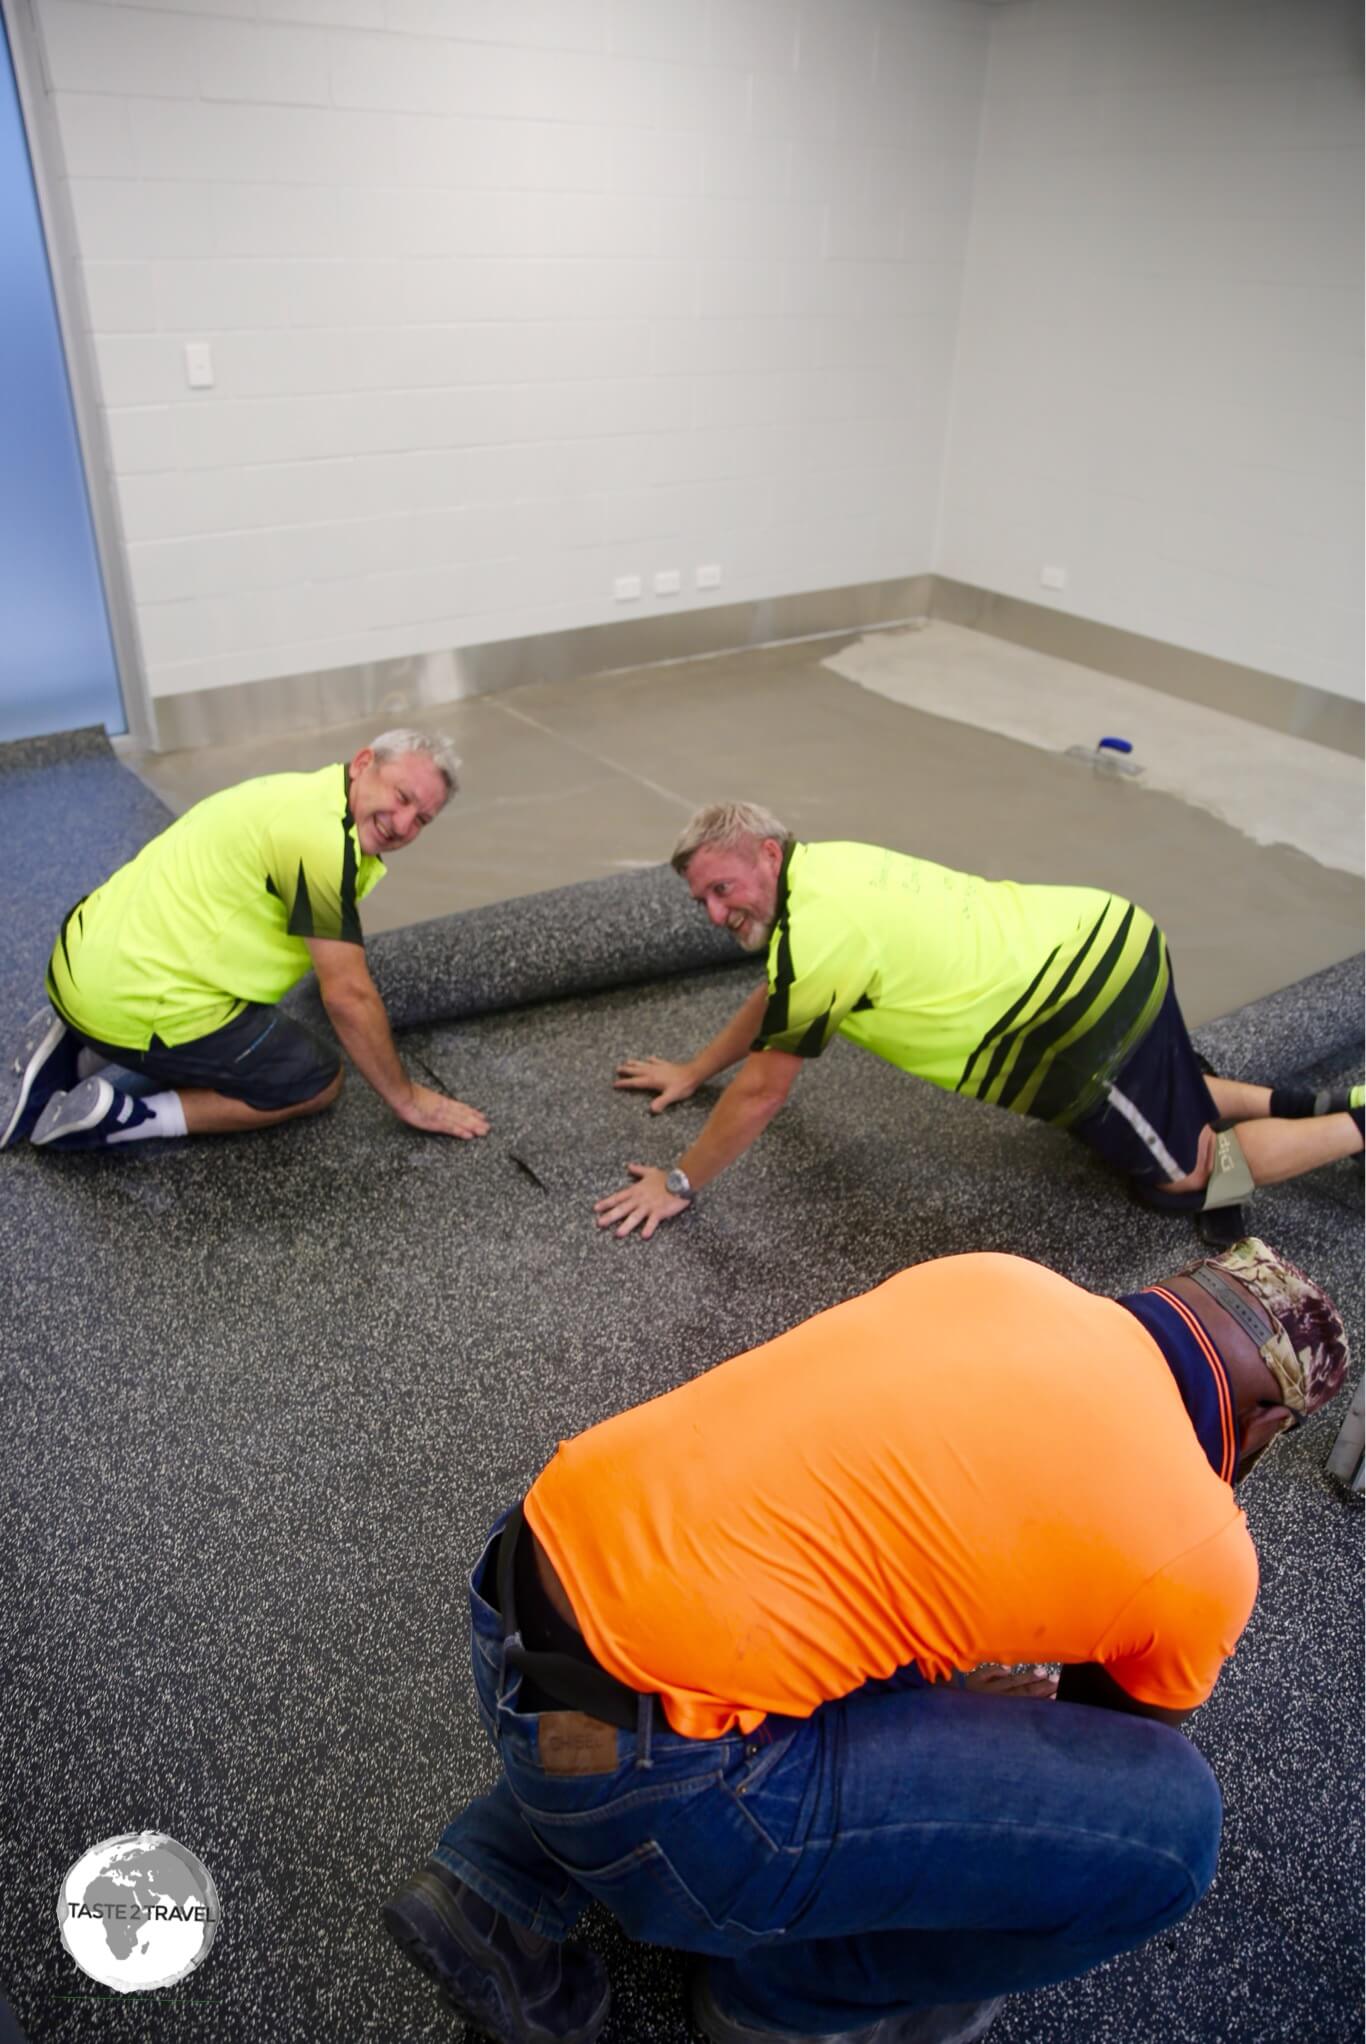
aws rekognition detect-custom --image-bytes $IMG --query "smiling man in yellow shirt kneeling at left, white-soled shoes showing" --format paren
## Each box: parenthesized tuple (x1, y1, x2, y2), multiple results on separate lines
(0, 732, 489, 1151)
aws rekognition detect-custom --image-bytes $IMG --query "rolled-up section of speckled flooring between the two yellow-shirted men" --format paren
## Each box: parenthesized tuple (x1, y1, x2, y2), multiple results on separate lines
(294, 867, 755, 1028)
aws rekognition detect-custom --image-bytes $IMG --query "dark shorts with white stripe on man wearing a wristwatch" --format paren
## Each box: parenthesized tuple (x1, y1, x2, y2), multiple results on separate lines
(1072, 981, 1219, 1202)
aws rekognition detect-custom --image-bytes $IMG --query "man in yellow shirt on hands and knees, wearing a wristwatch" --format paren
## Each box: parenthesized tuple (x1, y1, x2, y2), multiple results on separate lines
(595, 803, 1366, 1241)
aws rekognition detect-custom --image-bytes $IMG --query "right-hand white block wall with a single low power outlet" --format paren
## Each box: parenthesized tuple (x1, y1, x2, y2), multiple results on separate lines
(937, 0, 1362, 699)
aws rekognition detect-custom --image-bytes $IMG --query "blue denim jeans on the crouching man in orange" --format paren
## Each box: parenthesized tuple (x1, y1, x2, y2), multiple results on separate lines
(436, 1527, 1221, 2036)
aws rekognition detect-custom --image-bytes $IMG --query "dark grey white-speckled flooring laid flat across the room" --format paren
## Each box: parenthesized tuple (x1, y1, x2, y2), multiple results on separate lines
(0, 754, 1362, 2044)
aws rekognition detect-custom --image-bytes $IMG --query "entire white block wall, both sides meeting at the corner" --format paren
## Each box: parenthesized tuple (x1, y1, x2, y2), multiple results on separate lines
(21, 0, 1362, 719)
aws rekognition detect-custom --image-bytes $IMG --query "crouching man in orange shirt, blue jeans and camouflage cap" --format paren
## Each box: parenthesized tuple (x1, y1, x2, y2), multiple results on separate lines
(384, 1241, 1348, 2044)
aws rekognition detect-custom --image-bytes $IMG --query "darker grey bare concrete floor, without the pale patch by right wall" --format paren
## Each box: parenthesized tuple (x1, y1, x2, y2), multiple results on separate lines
(119, 640, 1362, 1024)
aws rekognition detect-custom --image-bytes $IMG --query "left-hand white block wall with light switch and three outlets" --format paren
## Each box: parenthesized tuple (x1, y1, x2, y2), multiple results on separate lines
(35, 0, 992, 695)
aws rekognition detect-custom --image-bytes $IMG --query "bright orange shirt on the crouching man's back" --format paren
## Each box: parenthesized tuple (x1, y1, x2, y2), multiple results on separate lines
(526, 1255, 1258, 1739)
